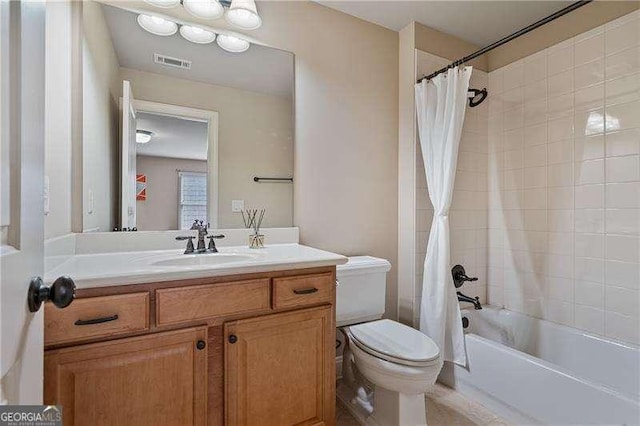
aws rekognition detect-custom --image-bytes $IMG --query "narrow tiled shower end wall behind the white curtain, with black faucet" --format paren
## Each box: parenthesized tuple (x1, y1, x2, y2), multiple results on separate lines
(414, 51, 490, 323)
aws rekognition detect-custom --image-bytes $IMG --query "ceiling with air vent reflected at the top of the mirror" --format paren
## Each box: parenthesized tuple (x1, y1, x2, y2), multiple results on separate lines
(102, 4, 293, 97)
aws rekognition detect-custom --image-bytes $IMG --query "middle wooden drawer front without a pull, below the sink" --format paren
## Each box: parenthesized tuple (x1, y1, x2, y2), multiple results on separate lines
(156, 278, 269, 325)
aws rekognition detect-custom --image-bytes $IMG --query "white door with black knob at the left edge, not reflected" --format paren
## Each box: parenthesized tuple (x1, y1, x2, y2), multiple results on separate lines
(0, 1, 45, 404)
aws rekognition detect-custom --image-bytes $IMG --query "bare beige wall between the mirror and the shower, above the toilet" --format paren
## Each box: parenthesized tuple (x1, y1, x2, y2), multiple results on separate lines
(256, 2, 398, 317)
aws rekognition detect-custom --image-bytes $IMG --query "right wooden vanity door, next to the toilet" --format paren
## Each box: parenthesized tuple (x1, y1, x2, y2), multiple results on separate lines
(225, 306, 335, 426)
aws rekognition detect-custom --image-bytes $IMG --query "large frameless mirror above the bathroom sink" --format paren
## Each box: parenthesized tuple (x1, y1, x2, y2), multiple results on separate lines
(82, 1, 294, 232)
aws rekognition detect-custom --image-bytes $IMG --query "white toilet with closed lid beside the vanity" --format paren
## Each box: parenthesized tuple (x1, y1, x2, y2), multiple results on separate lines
(336, 256, 441, 426)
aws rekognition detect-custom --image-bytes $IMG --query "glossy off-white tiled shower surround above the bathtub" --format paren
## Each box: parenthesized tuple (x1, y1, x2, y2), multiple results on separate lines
(417, 11, 640, 344)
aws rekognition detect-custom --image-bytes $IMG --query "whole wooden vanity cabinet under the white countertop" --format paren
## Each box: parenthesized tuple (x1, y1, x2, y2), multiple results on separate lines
(44, 267, 335, 426)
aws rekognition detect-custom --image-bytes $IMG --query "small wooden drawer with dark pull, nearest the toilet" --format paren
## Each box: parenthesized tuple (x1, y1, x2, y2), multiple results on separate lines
(273, 272, 336, 309)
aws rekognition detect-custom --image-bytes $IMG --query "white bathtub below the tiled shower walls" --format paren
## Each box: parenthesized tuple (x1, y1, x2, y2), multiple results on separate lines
(439, 306, 640, 425)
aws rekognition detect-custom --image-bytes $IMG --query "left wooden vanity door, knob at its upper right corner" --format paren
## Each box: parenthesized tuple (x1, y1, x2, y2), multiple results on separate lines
(44, 327, 207, 426)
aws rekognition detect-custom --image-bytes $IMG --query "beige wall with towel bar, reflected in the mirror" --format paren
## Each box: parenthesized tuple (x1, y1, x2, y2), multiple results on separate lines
(120, 68, 294, 228)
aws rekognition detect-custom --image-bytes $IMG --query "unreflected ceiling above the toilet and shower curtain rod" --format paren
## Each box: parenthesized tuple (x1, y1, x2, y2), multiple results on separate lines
(316, 0, 572, 46)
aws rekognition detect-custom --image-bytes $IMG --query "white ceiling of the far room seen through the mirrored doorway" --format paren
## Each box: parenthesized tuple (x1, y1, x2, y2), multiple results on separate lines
(136, 112, 208, 161)
